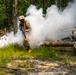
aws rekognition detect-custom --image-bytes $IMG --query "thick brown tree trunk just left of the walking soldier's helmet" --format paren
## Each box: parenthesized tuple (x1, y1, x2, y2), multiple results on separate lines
(12, 0, 18, 34)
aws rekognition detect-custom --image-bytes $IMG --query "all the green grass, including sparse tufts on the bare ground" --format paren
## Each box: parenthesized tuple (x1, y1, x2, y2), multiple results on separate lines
(0, 44, 74, 75)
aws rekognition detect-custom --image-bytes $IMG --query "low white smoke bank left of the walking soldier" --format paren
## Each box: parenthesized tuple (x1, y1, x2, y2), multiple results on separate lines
(0, 30, 24, 48)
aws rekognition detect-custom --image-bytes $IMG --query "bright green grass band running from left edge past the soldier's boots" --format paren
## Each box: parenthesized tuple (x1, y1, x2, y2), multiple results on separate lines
(0, 45, 57, 66)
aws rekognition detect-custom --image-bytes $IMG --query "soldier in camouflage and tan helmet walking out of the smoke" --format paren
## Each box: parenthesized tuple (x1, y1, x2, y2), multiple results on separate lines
(19, 16, 31, 52)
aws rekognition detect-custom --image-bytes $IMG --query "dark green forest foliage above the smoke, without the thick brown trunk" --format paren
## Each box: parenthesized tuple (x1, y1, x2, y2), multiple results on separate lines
(0, 0, 73, 29)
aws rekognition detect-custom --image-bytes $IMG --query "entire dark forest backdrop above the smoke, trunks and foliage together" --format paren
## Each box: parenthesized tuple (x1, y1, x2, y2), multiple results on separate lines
(0, 0, 73, 32)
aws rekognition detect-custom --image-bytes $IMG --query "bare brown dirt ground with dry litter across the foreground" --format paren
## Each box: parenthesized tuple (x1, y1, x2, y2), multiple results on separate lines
(0, 59, 76, 75)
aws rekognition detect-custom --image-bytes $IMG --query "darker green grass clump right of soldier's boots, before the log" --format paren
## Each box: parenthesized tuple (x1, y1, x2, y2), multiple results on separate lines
(31, 47, 57, 60)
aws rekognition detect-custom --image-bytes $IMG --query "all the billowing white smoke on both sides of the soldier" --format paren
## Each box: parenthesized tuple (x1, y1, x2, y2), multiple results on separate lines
(0, 0, 76, 48)
